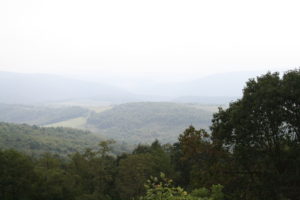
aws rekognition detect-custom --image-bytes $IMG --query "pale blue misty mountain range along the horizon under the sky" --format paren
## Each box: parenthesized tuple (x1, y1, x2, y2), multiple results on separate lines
(0, 71, 261, 105)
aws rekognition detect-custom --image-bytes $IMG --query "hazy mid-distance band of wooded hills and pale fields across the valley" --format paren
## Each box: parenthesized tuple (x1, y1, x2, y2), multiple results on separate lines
(0, 102, 217, 144)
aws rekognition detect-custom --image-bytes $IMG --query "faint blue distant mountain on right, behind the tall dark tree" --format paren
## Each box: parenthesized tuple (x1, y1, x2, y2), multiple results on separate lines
(132, 71, 261, 101)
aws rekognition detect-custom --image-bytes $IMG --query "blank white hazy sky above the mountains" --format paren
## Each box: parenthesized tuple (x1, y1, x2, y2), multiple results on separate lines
(0, 0, 300, 81)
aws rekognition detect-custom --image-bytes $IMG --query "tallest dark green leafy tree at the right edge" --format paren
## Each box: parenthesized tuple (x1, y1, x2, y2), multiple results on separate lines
(211, 70, 300, 199)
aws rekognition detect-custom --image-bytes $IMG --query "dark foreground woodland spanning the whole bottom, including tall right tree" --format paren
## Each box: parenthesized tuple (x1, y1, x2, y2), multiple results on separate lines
(0, 70, 300, 200)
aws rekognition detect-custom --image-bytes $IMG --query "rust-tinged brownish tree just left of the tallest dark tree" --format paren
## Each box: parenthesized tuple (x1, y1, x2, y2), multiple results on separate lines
(172, 126, 229, 190)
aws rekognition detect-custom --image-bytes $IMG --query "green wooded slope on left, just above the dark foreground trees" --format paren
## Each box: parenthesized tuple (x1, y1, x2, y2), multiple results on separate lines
(0, 122, 129, 156)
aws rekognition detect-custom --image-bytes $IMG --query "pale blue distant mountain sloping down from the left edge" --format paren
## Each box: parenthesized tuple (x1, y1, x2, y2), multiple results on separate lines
(0, 72, 135, 104)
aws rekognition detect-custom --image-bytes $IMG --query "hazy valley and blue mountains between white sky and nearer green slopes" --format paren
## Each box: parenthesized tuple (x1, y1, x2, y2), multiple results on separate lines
(0, 72, 266, 144)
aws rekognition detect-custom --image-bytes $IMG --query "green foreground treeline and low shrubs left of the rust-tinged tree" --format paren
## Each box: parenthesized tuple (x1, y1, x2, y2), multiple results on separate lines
(0, 138, 223, 200)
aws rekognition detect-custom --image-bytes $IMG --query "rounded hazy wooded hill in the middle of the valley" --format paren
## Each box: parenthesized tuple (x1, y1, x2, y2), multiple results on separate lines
(87, 102, 212, 143)
